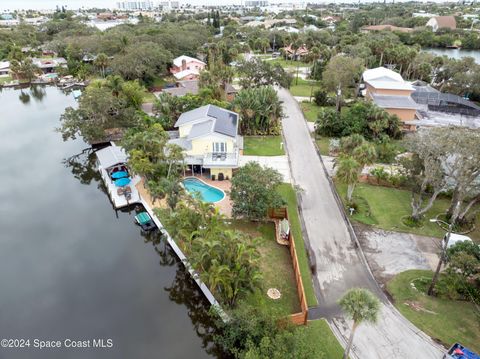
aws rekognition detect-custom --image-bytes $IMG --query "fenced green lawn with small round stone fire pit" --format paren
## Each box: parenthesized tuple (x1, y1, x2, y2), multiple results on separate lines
(232, 221, 301, 316)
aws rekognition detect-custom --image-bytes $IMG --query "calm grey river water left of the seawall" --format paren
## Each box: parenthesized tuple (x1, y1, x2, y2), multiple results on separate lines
(0, 87, 217, 359)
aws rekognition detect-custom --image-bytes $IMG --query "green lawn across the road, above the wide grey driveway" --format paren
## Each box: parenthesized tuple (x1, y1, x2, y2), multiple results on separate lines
(336, 183, 480, 240)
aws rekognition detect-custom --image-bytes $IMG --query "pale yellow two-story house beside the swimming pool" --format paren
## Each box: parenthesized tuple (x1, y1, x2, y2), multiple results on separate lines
(170, 105, 243, 179)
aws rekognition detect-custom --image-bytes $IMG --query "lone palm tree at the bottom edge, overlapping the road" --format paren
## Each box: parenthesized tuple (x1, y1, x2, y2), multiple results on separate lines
(338, 288, 380, 359)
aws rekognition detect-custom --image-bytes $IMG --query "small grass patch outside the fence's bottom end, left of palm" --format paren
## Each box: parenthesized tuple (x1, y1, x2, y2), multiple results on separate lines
(305, 319, 343, 359)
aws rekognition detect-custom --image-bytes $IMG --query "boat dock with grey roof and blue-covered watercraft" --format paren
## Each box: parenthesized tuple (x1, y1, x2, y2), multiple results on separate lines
(96, 142, 141, 209)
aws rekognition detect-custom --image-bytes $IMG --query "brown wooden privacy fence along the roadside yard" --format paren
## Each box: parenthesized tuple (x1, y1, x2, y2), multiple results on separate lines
(268, 207, 308, 325)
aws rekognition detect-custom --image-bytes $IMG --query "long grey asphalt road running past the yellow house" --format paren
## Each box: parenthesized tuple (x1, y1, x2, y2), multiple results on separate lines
(278, 89, 442, 359)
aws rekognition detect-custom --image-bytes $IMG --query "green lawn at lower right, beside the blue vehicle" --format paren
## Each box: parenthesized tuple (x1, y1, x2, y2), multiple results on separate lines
(387, 270, 480, 352)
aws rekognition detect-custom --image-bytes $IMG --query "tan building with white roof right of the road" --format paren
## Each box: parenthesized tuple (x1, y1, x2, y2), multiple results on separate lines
(362, 67, 419, 131)
